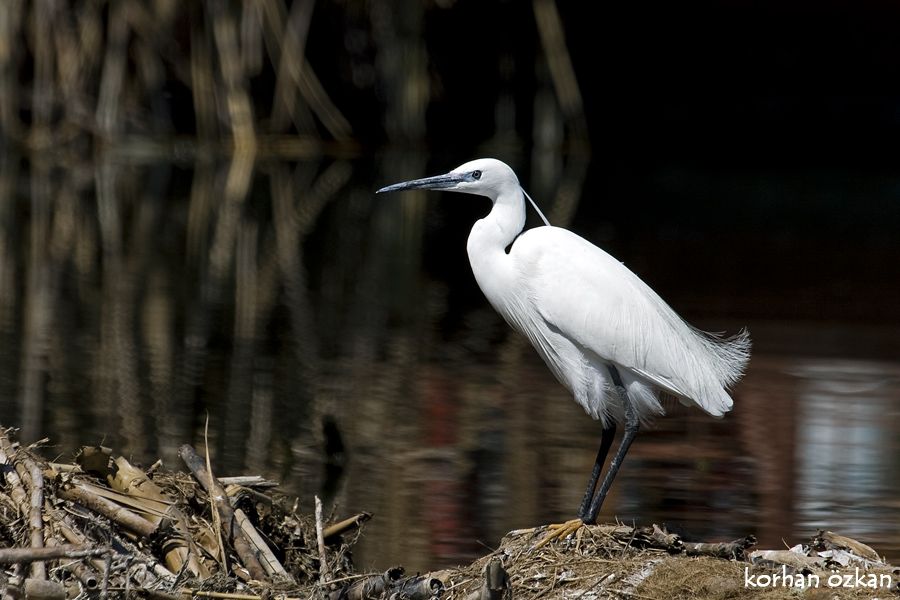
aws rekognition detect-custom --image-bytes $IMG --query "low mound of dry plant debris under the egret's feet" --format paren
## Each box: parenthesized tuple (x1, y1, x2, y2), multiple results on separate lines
(432, 524, 900, 600)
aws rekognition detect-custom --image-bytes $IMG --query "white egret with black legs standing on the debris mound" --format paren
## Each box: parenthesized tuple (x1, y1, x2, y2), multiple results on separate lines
(378, 158, 750, 540)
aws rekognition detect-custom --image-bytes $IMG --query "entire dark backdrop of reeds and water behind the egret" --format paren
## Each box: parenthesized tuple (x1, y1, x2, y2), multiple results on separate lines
(0, 0, 900, 570)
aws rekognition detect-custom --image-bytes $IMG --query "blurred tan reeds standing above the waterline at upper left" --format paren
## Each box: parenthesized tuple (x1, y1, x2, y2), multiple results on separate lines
(0, 0, 356, 160)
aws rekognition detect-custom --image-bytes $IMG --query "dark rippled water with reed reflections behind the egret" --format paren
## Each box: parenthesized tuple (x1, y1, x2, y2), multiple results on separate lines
(0, 156, 900, 571)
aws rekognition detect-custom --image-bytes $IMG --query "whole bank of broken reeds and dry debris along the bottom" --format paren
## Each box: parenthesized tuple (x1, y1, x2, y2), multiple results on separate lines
(0, 430, 900, 600)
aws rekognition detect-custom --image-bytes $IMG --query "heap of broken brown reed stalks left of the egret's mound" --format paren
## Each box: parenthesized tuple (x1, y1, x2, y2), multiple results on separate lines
(0, 430, 441, 600)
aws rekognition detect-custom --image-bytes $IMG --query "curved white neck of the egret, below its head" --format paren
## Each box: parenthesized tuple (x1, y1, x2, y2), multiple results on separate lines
(466, 185, 525, 316)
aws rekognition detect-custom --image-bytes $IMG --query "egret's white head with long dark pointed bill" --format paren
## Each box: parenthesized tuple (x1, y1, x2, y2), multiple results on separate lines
(378, 158, 520, 200)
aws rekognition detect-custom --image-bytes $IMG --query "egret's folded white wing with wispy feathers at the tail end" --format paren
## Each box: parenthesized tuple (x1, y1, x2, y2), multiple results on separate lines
(516, 227, 749, 414)
